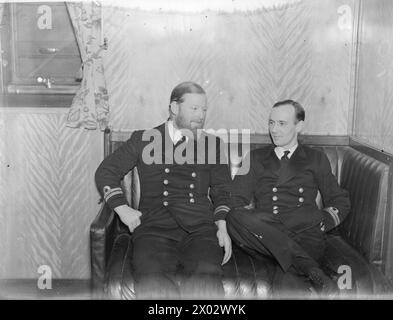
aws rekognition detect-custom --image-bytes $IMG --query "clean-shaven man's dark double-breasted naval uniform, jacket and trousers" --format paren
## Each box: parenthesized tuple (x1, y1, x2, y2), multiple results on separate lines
(227, 144, 350, 292)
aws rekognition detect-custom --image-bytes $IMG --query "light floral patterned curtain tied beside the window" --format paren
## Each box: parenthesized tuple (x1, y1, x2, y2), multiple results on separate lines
(66, 1, 109, 129)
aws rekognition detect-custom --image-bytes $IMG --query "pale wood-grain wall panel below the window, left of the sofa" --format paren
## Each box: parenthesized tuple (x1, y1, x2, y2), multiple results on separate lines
(0, 108, 103, 278)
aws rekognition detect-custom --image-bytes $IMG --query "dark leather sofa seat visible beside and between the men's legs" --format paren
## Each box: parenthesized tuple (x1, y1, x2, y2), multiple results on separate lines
(105, 233, 392, 300)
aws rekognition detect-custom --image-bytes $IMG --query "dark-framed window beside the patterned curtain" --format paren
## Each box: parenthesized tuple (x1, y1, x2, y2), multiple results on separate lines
(1, 2, 82, 106)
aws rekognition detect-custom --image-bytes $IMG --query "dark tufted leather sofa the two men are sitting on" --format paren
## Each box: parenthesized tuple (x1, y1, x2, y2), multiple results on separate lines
(90, 130, 393, 299)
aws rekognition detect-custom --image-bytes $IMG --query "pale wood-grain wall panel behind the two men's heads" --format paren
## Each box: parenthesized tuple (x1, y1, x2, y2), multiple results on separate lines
(103, 0, 355, 135)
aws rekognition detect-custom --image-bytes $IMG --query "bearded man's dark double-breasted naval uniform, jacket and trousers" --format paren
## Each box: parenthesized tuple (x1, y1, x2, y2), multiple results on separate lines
(96, 120, 231, 298)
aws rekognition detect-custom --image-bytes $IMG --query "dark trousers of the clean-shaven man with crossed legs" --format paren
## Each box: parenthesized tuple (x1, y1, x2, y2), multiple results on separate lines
(226, 208, 325, 292)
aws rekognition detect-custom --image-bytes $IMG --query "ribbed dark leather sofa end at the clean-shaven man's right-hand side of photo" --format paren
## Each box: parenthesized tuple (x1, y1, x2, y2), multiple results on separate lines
(339, 148, 389, 271)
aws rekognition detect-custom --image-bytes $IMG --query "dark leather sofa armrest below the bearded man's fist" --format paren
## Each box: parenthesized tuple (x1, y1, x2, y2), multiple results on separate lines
(90, 204, 117, 292)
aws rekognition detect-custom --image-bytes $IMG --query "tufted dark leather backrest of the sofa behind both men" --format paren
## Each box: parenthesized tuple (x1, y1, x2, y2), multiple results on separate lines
(110, 141, 390, 271)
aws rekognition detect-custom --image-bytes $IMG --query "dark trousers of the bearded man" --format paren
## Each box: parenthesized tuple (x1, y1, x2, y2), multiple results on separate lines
(132, 225, 224, 299)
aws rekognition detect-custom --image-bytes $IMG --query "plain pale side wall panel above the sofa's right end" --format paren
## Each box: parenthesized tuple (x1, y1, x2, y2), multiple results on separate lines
(354, 0, 393, 154)
